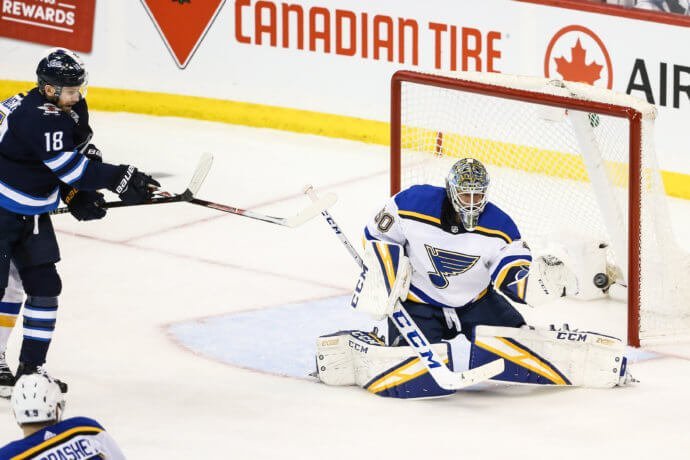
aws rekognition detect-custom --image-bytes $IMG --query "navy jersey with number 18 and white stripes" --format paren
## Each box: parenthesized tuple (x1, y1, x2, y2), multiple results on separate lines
(0, 88, 122, 215)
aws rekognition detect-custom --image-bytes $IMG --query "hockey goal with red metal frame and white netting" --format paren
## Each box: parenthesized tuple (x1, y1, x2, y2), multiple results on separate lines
(390, 71, 690, 346)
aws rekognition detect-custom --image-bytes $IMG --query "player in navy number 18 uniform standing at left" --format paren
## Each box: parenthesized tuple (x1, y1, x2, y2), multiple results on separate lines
(0, 48, 160, 391)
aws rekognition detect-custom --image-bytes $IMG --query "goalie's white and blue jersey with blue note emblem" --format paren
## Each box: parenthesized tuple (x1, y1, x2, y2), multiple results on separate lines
(365, 185, 532, 308)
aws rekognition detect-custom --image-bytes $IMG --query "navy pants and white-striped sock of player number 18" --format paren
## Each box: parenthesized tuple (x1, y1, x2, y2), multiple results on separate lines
(0, 208, 62, 365)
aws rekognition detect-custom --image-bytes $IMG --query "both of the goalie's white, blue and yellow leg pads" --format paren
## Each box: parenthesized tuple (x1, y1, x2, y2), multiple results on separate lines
(316, 326, 635, 398)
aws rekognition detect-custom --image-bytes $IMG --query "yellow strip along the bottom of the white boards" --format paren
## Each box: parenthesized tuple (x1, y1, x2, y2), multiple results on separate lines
(0, 80, 690, 199)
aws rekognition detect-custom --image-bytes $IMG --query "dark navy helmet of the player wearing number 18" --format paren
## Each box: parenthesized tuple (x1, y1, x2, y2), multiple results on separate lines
(36, 48, 88, 96)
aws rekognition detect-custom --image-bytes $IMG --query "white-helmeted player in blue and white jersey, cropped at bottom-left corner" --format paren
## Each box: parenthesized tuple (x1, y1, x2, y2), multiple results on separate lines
(0, 374, 125, 460)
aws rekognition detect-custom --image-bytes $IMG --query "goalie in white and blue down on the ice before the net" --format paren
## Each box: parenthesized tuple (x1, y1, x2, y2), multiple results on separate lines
(316, 158, 634, 398)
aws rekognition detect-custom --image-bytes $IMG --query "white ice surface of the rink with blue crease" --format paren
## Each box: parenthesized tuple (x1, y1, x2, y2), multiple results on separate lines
(0, 112, 690, 460)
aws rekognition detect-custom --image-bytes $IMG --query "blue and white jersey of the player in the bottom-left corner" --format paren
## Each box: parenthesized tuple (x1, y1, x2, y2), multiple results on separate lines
(0, 417, 125, 460)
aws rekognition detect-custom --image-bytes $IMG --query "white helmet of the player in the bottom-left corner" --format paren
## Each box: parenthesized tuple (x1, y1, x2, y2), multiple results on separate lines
(12, 374, 65, 425)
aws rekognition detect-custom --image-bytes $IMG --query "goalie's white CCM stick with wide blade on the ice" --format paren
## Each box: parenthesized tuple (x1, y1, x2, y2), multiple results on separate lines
(304, 185, 505, 390)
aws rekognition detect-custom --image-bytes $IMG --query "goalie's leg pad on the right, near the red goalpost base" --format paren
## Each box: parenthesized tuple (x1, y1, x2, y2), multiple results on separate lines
(469, 326, 630, 388)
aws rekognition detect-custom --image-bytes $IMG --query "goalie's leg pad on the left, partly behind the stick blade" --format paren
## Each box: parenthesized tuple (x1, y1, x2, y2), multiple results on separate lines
(316, 331, 454, 398)
